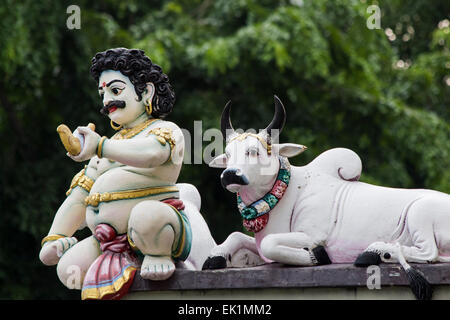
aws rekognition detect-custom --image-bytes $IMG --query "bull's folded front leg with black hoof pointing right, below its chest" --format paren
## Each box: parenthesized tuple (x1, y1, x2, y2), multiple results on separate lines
(261, 232, 331, 266)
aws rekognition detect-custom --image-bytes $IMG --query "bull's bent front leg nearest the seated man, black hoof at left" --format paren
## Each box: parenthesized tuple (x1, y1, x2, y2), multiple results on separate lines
(202, 232, 264, 270)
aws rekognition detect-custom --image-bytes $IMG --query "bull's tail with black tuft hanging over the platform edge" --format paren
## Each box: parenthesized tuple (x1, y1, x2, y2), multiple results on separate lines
(397, 243, 433, 300)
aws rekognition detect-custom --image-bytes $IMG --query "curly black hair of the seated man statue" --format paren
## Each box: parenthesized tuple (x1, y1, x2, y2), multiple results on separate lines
(90, 48, 175, 118)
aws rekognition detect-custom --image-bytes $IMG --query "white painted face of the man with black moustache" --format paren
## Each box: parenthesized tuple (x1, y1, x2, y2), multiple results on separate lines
(98, 70, 145, 125)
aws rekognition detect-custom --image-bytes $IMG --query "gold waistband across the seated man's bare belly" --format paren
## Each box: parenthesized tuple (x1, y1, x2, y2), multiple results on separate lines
(84, 186, 178, 207)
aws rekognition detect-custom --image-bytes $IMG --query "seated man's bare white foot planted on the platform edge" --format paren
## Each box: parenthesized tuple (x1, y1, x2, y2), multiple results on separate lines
(141, 255, 175, 280)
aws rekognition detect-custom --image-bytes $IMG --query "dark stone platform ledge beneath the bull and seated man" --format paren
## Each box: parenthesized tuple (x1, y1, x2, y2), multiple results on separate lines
(130, 263, 450, 293)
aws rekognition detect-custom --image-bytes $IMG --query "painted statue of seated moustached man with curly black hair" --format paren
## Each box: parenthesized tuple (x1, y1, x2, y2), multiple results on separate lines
(39, 48, 206, 299)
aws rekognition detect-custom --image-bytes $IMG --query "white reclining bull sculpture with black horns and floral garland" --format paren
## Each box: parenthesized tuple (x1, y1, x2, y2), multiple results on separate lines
(204, 96, 450, 299)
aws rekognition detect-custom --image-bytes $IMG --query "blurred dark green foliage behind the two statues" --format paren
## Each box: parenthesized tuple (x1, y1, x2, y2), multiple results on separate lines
(0, 0, 450, 299)
